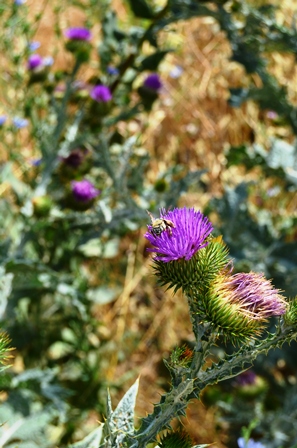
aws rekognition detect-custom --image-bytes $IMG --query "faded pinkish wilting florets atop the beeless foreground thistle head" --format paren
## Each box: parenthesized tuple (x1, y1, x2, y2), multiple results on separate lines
(223, 272, 286, 320)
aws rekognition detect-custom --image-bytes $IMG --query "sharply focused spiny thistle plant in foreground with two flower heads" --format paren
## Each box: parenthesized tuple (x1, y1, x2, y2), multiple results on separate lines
(74, 207, 297, 448)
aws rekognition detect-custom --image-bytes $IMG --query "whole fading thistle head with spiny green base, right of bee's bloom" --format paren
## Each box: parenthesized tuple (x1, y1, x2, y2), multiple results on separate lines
(202, 271, 287, 342)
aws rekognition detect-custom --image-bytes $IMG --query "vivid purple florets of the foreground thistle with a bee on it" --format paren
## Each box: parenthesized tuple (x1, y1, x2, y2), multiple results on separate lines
(144, 207, 213, 263)
